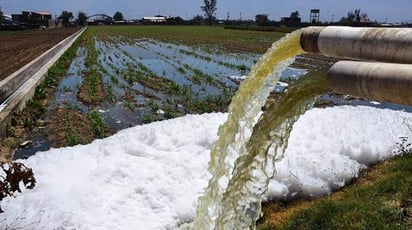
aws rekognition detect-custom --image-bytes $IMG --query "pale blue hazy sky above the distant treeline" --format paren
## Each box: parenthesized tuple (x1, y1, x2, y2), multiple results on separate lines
(0, 0, 412, 22)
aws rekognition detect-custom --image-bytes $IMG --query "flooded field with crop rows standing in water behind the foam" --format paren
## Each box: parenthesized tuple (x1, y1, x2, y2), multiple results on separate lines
(8, 27, 307, 157)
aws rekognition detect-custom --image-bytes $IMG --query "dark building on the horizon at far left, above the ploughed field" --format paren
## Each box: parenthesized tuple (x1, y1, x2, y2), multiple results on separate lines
(11, 11, 56, 28)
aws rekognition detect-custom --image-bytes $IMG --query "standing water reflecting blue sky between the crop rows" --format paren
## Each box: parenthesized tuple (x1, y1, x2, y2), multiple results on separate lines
(15, 37, 307, 158)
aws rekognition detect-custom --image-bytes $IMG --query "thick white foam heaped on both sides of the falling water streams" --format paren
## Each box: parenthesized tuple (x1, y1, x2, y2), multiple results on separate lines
(0, 106, 412, 230)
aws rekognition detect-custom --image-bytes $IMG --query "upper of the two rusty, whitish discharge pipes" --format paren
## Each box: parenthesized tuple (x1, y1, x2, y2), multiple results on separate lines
(300, 26, 412, 64)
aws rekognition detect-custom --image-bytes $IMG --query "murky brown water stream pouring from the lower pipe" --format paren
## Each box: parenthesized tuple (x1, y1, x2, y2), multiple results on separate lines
(216, 71, 327, 229)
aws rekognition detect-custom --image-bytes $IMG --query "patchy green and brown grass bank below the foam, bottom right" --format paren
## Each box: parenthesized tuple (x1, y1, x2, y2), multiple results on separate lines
(259, 141, 412, 229)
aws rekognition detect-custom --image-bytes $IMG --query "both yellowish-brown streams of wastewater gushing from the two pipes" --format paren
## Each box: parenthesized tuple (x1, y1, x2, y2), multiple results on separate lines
(192, 30, 326, 229)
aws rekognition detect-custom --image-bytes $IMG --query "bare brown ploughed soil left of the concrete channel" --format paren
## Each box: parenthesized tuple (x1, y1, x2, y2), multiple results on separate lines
(0, 27, 79, 80)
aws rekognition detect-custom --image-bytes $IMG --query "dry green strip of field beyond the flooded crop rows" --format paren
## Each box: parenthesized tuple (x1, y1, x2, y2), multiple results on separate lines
(89, 26, 285, 53)
